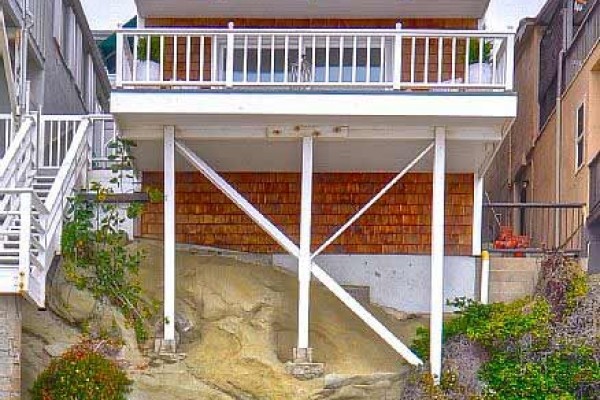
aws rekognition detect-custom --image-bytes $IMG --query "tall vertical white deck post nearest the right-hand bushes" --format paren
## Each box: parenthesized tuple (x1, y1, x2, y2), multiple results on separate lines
(429, 127, 446, 383)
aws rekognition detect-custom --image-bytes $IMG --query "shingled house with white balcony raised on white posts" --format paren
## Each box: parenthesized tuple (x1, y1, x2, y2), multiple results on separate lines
(111, 0, 517, 375)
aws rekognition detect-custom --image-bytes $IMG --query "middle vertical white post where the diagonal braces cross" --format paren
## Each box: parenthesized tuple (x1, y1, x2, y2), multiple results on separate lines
(295, 137, 313, 362)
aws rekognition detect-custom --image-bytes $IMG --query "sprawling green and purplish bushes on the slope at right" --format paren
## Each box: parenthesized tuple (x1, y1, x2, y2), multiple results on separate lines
(403, 254, 600, 400)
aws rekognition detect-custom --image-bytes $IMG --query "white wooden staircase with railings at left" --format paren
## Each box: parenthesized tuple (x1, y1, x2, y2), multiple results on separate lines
(0, 115, 98, 308)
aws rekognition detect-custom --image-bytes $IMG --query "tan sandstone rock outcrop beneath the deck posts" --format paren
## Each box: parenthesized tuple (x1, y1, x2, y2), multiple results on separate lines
(23, 241, 424, 400)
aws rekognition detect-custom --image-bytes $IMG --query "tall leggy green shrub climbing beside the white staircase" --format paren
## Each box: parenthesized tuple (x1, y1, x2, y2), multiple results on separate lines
(61, 139, 156, 342)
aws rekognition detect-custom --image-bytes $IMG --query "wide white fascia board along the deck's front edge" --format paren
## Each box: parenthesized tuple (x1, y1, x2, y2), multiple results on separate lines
(111, 90, 517, 118)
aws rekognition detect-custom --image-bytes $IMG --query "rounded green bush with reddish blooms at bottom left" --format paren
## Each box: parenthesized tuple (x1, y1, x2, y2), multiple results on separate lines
(31, 342, 133, 400)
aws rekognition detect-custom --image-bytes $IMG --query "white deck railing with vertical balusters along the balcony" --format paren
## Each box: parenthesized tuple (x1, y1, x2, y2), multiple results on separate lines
(116, 25, 514, 91)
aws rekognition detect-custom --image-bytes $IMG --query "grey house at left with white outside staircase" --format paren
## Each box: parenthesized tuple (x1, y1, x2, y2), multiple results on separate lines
(0, 0, 110, 398)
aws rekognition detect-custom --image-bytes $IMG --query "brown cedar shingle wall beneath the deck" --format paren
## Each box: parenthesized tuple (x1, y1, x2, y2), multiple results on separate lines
(141, 172, 473, 255)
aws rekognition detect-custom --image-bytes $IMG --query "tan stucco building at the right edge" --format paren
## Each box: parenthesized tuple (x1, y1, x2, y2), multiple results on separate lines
(486, 0, 600, 272)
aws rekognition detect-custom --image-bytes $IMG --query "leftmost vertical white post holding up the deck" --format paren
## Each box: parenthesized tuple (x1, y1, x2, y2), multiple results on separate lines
(163, 126, 176, 345)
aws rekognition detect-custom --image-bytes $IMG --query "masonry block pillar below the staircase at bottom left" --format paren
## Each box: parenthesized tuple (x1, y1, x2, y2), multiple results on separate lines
(0, 295, 21, 400)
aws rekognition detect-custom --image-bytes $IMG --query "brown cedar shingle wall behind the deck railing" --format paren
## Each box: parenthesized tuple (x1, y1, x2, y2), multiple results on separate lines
(146, 18, 477, 82)
